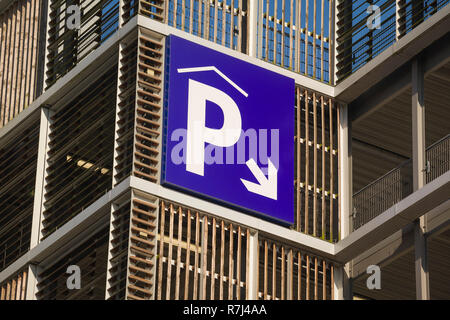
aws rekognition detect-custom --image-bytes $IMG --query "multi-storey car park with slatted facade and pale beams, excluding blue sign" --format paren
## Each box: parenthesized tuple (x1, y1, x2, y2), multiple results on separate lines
(0, 0, 450, 300)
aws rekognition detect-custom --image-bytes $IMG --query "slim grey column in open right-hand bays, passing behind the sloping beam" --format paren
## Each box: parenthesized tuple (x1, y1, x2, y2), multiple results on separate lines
(411, 58, 430, 300)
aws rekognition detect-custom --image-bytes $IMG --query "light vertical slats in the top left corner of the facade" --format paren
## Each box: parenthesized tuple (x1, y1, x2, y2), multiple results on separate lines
(0, 0, 46, 128)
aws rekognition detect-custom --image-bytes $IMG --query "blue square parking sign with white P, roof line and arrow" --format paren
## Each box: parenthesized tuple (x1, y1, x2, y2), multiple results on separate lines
(162, 35, 295, 224)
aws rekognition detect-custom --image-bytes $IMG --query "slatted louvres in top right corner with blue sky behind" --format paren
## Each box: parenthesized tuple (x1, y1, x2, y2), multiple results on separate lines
(336, 0, 450, 82)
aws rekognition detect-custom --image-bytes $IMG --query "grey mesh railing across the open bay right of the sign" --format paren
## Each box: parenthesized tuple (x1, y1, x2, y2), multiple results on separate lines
(352, 134, 450, 230)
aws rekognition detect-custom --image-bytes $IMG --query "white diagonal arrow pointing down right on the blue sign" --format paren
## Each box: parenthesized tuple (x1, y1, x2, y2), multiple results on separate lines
(241, 159, 278, 200)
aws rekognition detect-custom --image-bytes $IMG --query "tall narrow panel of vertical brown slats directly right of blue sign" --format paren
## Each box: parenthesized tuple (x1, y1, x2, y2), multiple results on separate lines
(295, 87, 339, 241)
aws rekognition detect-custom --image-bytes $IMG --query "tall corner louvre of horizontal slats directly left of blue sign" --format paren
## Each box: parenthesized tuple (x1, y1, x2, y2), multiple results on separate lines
(114, 29, 164, 188)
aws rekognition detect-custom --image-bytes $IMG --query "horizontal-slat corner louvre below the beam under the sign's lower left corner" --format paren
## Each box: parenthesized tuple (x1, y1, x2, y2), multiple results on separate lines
(106, 190, 158, 300)
